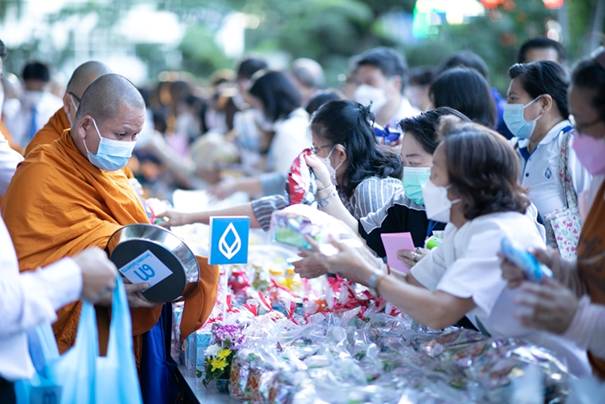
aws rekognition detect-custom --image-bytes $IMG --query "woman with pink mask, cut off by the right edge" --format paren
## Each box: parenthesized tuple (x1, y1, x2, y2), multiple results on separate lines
(503, 49, 605, 379)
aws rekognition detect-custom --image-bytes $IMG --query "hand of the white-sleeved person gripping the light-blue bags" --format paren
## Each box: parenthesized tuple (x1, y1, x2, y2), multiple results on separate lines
(73, 247, 117, 303)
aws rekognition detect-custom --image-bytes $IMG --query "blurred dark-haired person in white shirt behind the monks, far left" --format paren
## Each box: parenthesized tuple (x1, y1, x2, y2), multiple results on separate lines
(5, 61, 63, 148)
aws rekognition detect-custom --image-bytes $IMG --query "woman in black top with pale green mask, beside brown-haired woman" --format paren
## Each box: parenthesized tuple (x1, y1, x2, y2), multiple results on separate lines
(299, 107, 468, 262)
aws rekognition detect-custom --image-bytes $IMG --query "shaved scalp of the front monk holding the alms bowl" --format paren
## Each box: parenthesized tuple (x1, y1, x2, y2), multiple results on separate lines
(76, 73, 145, 121)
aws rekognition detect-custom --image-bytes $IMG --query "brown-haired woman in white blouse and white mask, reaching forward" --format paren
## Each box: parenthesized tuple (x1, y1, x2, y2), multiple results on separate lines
(298, 119, 588, 374)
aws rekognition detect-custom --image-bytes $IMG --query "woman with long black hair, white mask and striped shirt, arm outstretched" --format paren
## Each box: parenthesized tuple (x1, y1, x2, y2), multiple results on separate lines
(166, 101, 402, 230)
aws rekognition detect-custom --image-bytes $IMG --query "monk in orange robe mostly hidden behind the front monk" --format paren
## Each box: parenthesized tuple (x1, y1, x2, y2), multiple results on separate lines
(24, 60, 111, 156)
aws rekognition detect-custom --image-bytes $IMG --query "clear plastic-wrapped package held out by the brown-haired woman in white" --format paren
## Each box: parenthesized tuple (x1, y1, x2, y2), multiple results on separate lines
(271, 204, 363, 255)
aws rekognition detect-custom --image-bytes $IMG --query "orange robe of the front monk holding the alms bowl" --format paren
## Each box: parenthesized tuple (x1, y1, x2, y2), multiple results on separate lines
(3, 131, 218, 356)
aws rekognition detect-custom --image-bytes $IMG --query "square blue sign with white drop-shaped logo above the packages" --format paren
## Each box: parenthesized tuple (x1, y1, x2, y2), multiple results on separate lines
(208, 216, 250, 265)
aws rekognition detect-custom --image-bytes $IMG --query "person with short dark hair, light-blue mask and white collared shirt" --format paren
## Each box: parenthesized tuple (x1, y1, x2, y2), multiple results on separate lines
(504, 61, 591, 252)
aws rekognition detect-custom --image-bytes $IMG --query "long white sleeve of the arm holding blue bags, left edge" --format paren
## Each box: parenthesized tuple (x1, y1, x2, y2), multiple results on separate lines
(0, 258, 82, 338)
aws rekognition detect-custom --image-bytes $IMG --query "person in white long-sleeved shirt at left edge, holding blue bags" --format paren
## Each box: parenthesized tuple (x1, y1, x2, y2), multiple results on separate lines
(0, 218, 116, 403)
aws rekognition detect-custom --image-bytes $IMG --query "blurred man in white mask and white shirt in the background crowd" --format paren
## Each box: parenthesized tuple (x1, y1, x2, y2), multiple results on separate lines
(353, 48, 420, 129)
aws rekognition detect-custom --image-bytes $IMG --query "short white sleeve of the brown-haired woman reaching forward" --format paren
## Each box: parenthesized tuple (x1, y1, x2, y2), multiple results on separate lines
(437, 229, 506, 315)
